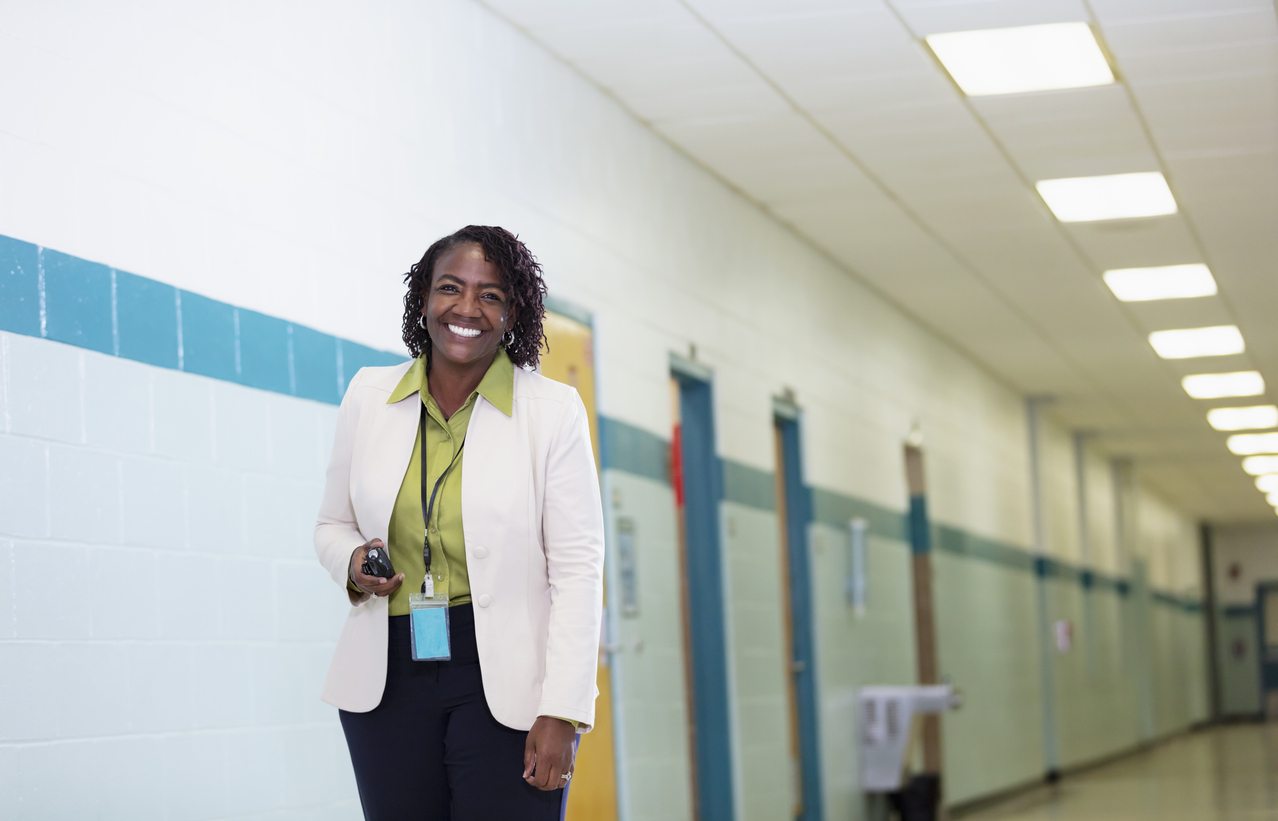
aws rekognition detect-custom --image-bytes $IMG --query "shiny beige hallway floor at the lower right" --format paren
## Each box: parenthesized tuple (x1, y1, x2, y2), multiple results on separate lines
(962, 724, 1278, 821)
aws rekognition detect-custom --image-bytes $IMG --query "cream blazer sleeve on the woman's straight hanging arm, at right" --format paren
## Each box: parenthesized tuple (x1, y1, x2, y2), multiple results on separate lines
(537, 391, 603, 731)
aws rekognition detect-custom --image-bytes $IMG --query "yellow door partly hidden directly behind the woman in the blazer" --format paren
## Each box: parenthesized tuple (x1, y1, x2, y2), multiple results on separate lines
(542, 311, 617, 821)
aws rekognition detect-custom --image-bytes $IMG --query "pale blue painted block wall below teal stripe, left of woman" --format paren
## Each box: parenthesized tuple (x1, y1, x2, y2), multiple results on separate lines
(0, 334, 359, 821)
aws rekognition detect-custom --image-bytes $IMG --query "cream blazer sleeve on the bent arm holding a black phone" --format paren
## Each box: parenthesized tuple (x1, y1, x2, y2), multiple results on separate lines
(314, 368, 371, 605)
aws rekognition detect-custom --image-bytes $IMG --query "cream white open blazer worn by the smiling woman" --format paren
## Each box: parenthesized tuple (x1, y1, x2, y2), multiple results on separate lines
(314, 362, 603, 730)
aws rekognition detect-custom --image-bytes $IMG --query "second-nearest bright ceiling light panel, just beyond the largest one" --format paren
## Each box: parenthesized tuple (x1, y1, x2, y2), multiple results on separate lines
(1034, 171, 1176, 223)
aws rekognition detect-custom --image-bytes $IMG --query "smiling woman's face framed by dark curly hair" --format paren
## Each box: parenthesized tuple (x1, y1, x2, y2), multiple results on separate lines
(422, 243, 515, 364)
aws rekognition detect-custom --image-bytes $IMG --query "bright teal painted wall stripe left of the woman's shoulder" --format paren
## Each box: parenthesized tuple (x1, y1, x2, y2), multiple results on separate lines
(0, 235, 405, 404)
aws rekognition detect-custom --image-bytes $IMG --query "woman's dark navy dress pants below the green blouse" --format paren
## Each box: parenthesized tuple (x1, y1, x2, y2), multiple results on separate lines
(339, 605, 564, 821)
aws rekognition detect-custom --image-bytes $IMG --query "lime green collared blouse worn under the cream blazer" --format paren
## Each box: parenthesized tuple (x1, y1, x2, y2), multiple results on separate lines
(386, 349, 515, 615)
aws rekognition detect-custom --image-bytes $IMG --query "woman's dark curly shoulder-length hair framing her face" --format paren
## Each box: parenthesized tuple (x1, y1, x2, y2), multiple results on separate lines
(404, 225, 546, 370)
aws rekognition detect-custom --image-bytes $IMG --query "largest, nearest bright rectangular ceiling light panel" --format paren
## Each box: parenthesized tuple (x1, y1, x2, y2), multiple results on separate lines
(927, 23, 1114, 97)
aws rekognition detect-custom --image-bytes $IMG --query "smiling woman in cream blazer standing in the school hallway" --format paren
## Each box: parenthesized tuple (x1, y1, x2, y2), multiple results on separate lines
(316, 225, 603, 820)
